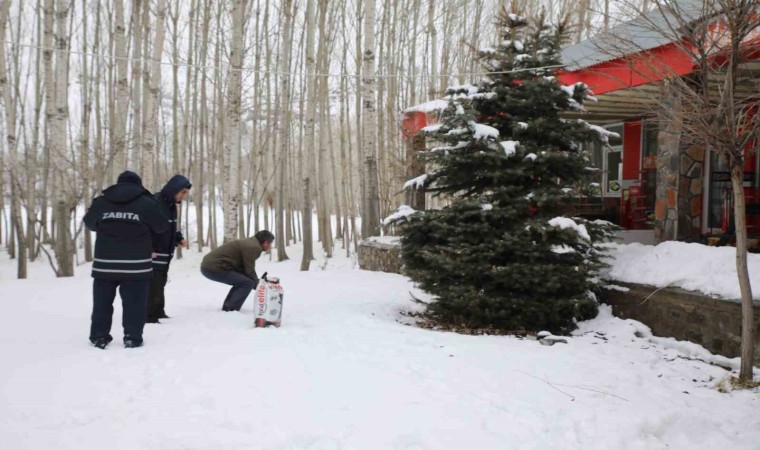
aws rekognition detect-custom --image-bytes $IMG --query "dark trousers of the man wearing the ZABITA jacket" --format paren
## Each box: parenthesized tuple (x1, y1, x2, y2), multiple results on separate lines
(90, 278, 149, 343)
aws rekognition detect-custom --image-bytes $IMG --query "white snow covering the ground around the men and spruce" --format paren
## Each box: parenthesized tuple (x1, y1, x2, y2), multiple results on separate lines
(0, 237, 760, 450)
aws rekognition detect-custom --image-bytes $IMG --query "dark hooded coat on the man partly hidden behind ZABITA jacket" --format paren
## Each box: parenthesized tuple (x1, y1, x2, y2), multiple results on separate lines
(148, 175, 193, 272)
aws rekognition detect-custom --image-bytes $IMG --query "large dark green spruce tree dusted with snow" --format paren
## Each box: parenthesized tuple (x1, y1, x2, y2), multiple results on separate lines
(396, 14, 612, 333)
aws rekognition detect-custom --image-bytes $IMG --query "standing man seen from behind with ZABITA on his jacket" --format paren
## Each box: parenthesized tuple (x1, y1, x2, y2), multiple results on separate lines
(84, 171, 169, 348)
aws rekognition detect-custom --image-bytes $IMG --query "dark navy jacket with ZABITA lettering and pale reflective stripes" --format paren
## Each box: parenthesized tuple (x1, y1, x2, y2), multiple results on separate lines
(84, 178, 169, 281)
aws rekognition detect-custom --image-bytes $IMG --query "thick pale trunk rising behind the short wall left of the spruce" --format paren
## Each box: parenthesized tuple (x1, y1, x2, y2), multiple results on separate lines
(362, 0, 380, 237)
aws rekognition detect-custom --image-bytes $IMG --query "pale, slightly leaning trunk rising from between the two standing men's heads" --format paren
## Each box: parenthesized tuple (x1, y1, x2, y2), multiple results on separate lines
(142, 0, 166, 191)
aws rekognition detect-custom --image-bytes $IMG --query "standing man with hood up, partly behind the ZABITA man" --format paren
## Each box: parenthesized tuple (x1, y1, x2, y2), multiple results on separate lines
(147, 175, 193, 323)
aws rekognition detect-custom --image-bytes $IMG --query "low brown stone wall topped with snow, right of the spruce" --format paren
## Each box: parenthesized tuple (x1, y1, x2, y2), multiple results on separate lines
(601, 282, 760, 361)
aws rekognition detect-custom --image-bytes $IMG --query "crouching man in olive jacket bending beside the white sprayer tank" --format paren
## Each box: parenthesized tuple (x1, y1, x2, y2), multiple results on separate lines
(201, 230, 274, 311)
